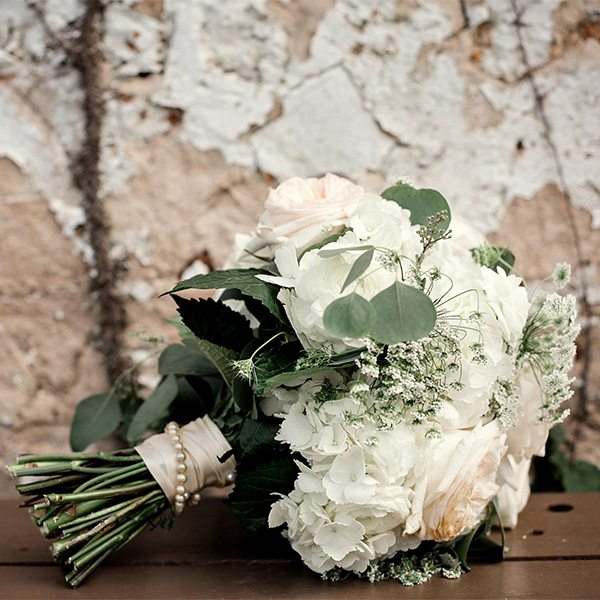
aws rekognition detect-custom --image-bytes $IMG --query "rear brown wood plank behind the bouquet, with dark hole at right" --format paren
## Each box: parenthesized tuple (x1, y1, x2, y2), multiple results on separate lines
(0, 493, 600, 564)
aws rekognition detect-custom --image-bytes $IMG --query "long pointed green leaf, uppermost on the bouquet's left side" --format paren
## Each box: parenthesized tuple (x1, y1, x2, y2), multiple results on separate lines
(162, 269, 287, 323)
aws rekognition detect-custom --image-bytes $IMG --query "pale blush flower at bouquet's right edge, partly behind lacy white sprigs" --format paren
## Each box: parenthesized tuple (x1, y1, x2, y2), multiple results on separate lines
(506, 366, 550, 460)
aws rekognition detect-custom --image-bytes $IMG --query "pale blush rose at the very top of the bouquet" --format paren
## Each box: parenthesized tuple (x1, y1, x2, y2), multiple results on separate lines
(258, 173, 365, 252)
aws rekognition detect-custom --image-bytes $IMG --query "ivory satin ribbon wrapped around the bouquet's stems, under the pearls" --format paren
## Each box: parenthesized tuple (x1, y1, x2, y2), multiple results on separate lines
(135, 415, 236, 504)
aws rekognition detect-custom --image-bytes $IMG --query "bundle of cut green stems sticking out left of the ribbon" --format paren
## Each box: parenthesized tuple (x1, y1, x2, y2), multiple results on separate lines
(7, 449, 169, 588)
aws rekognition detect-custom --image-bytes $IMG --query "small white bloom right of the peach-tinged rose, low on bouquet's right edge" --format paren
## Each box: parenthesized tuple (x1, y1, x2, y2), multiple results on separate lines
(496, 454, 531, 528)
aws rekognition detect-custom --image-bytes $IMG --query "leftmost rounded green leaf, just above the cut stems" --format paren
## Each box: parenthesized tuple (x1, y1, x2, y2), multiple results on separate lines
(69, 390, 121, 452)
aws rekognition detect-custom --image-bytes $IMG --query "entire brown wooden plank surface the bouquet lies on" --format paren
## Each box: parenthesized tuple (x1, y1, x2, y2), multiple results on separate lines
(0, 494, 600, 600)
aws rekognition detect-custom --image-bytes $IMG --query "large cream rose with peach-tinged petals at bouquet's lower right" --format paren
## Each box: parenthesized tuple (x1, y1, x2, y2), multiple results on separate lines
(414, 421, 506, 542)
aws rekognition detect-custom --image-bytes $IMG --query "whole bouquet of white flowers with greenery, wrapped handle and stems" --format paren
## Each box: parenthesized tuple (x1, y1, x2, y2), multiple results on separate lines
(10, 174, 578, 586)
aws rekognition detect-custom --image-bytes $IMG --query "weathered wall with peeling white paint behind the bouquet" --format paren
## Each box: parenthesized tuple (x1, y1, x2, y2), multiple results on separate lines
(0, 0, 600, 493)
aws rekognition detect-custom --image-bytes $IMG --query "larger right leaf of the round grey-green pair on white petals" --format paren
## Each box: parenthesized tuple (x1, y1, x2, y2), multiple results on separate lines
(370, 281, 436, 344)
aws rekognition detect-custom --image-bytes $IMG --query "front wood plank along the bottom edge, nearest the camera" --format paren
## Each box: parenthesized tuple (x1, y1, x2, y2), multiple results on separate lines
(0, 560, 600, 600)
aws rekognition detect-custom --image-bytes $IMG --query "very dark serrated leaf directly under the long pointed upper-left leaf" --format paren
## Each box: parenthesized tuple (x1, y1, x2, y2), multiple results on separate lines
(172, 294, 252, 352)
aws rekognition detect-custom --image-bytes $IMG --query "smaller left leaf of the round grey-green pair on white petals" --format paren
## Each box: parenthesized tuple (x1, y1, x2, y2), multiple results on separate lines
(323, 292, 376, 339)
